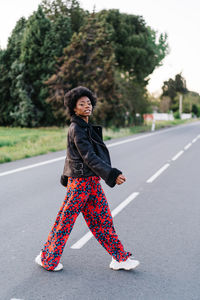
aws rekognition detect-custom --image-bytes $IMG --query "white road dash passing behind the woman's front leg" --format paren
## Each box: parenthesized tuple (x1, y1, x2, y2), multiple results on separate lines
(71, 192, 139, 249)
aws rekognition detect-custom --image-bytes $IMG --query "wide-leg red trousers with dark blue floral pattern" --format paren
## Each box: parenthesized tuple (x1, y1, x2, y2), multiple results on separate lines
(41, 176, 132, 270)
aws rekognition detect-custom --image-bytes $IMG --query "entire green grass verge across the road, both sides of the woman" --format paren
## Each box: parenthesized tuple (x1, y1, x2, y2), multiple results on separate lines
(0, 120, 197, 163)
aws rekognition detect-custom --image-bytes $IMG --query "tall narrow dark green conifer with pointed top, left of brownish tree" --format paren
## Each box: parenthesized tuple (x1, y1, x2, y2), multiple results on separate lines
(8, 7, 51, 126)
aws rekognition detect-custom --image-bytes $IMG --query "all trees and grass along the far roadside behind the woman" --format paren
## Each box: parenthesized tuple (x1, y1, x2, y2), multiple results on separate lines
(0, 0, 200, 163)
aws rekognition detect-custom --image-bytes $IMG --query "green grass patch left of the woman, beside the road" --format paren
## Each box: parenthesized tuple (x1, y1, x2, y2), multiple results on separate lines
(0, 127, 67, 163)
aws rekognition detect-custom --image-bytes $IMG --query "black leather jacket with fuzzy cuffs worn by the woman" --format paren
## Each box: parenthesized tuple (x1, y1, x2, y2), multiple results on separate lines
(61, 115, 122, 187)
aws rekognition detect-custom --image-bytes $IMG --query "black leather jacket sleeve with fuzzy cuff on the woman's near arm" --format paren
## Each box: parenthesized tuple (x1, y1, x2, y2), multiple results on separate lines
(73, 127, 122, 187)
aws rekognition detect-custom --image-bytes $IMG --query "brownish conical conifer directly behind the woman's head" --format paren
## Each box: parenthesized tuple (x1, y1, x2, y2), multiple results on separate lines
(47, 14, 117, 125)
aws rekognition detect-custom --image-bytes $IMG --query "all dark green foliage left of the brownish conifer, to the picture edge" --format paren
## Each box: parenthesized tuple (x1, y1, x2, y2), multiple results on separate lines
(0, 7, 72, 127)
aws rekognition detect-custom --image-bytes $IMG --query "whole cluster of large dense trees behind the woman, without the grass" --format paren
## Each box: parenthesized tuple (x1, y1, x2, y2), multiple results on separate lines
(0, 0, 168, 127)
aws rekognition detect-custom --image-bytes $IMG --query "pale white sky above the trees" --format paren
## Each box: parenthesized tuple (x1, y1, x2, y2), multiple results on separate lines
(0, 0, 200, 95)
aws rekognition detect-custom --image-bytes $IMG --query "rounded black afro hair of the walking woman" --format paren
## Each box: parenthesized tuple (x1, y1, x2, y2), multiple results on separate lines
(64, 86, 97, 116)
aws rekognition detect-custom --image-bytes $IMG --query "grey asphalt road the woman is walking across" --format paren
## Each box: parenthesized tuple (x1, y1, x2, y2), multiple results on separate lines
(0, 122, 200, 300)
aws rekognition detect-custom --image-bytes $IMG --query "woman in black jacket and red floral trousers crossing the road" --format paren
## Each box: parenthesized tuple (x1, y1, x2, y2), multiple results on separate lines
(35, 86, 139, 271)
